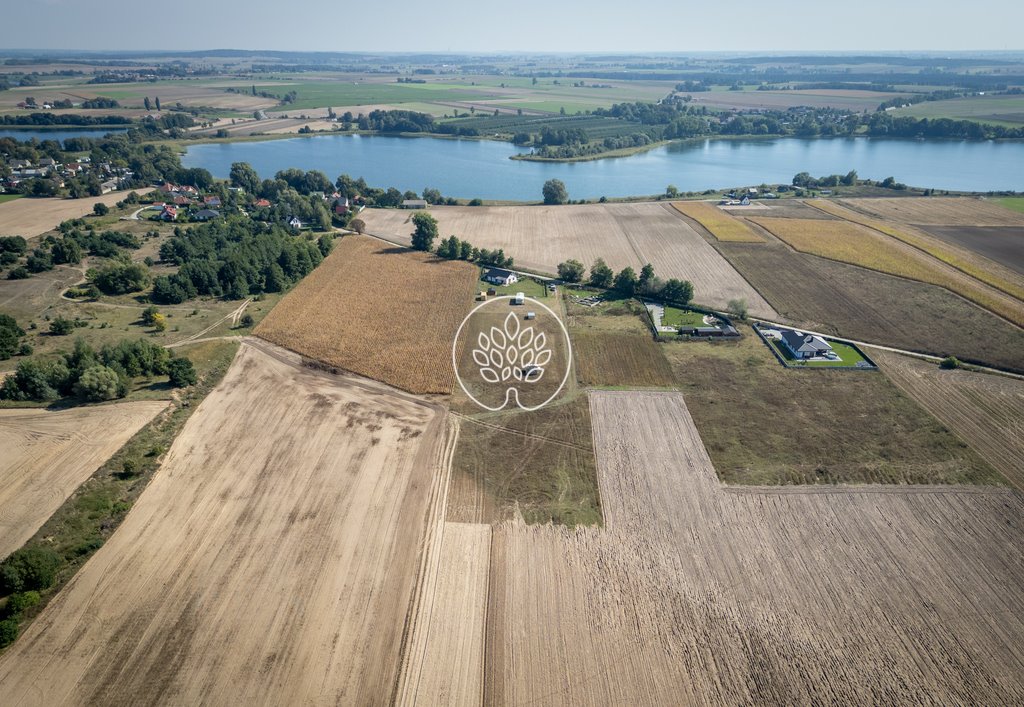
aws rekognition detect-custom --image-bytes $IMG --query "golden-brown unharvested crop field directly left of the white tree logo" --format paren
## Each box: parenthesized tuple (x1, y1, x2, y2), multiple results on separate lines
(255, 236, 479, 392)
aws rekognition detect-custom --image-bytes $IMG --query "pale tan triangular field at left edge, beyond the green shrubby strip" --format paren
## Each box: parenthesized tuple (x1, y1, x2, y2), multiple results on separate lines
(0, 402, 167, 558)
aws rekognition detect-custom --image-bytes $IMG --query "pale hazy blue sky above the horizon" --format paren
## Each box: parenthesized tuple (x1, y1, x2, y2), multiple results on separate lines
(0, 0, 1024, 53)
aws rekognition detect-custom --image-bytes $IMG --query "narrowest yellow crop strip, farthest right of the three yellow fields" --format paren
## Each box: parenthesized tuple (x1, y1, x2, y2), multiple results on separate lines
(808, 201, 1024, 300)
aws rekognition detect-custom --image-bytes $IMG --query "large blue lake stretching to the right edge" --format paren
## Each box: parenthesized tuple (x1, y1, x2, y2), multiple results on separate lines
(182, 135, 1024, 201)
